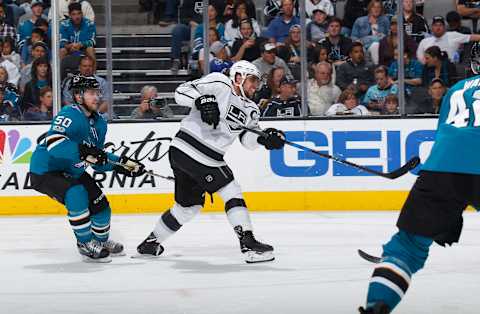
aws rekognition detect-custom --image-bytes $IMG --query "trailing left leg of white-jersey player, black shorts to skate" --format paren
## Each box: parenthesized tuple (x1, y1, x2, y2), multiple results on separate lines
(137, 167, 205, 256)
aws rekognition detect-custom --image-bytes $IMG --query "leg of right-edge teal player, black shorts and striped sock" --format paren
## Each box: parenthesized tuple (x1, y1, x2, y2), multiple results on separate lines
(360, 171, 471, 314)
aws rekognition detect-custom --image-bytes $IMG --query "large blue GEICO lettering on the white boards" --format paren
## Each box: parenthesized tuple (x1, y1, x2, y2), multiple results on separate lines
(270, 130, 435, 177)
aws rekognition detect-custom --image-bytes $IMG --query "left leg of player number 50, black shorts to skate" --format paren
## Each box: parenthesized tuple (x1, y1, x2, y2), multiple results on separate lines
(32, 173, 110, 262)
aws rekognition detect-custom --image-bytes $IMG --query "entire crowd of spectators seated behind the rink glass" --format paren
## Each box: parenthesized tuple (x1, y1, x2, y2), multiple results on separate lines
(0, 0, 480, 121)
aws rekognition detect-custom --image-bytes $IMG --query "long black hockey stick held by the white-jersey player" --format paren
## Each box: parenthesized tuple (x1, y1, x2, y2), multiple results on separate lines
(238, 125, 420, 180)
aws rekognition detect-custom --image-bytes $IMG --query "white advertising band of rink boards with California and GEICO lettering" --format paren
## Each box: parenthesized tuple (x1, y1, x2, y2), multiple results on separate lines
(0, 119, 436, 196)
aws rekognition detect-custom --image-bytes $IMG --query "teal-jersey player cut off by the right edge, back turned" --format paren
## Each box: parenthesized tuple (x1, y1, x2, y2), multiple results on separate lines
(360, 43, 480, 314)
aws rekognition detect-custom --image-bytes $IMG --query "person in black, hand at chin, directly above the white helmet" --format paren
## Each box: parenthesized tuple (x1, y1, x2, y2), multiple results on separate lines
(231, 19, 262, 62)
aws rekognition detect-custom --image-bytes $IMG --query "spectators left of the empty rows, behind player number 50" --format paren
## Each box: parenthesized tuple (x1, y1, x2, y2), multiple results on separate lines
(0, 0, 102, 121)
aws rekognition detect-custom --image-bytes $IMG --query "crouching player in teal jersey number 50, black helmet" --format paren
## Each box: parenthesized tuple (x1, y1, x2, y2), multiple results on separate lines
(30, 75, 145, 262)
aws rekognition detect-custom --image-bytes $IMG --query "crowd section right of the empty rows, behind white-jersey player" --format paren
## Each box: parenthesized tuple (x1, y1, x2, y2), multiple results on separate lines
(145, 0, 480, 117)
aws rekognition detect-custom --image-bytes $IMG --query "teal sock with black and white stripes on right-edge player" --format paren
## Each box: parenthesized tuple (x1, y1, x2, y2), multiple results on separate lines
(367, 231, 433, 311)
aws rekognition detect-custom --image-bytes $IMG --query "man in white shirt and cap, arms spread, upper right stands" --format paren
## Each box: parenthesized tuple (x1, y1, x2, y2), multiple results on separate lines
(417, 16, 480, 64)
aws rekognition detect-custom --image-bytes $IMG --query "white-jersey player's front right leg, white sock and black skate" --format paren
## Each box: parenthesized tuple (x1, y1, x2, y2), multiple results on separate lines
(218, 178, 275, 263)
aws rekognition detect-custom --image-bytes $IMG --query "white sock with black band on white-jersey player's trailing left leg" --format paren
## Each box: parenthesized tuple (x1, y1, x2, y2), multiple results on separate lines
(153, 203, 202, 242)
